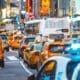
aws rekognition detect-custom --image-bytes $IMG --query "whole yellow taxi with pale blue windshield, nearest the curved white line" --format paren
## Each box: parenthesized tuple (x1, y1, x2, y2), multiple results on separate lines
(23, 40, 42, 69)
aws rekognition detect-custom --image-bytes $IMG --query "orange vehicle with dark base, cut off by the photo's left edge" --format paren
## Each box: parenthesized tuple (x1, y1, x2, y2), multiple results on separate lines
(0, 37, 4, 68)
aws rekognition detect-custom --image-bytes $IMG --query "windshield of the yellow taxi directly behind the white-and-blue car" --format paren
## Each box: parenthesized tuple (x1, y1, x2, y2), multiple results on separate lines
(49, 45, 64, 53)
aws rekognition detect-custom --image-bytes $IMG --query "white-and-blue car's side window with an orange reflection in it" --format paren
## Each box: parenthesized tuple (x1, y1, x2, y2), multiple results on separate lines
(37, 61, 57, 80)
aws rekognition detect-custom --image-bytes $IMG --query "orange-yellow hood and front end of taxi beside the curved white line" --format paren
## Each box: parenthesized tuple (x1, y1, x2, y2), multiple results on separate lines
(23, 48, 39, 69)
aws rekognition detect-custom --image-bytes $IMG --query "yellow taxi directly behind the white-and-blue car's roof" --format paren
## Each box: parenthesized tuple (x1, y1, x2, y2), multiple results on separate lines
(40, 41, 66, 63)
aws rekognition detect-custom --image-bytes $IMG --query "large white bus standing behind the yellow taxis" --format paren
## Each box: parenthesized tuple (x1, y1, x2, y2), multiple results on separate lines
(25, 17, 70, 36)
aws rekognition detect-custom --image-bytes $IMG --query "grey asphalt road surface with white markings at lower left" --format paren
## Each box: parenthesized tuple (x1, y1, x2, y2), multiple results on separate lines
(0, 51, 36, 80)
